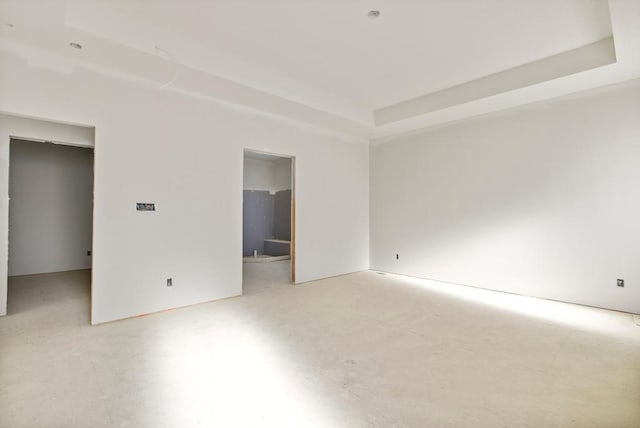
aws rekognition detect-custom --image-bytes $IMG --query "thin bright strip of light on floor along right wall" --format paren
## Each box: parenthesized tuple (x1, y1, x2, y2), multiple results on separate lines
(387, 274, 640, 340)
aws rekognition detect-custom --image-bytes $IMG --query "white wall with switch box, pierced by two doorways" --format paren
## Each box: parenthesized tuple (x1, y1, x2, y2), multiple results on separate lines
(0, 45, 369, 323)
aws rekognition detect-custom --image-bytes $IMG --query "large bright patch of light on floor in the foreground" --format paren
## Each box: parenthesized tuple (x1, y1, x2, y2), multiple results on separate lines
(157, 319, 340, 427)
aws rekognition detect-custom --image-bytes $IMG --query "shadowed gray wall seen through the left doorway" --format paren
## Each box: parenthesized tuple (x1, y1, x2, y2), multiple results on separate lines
(8, 139, 93, 276)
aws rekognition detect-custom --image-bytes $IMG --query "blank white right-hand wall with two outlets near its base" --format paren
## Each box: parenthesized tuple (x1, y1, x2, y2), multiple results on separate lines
(370, 80, 640, 313)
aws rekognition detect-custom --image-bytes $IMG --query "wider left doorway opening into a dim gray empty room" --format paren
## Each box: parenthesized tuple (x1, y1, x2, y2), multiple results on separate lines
(7, 138, 94, 320)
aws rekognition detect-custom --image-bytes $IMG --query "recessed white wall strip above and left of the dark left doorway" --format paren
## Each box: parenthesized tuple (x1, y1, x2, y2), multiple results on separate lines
(0, 113, 94, 315)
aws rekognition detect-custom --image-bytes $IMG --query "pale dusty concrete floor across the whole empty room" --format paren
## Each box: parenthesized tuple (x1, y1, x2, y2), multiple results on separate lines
(0, 270, 640, 428)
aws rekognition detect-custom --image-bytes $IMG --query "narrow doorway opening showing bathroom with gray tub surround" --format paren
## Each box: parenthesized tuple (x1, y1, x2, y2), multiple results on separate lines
(242, 150, 295, 293)
